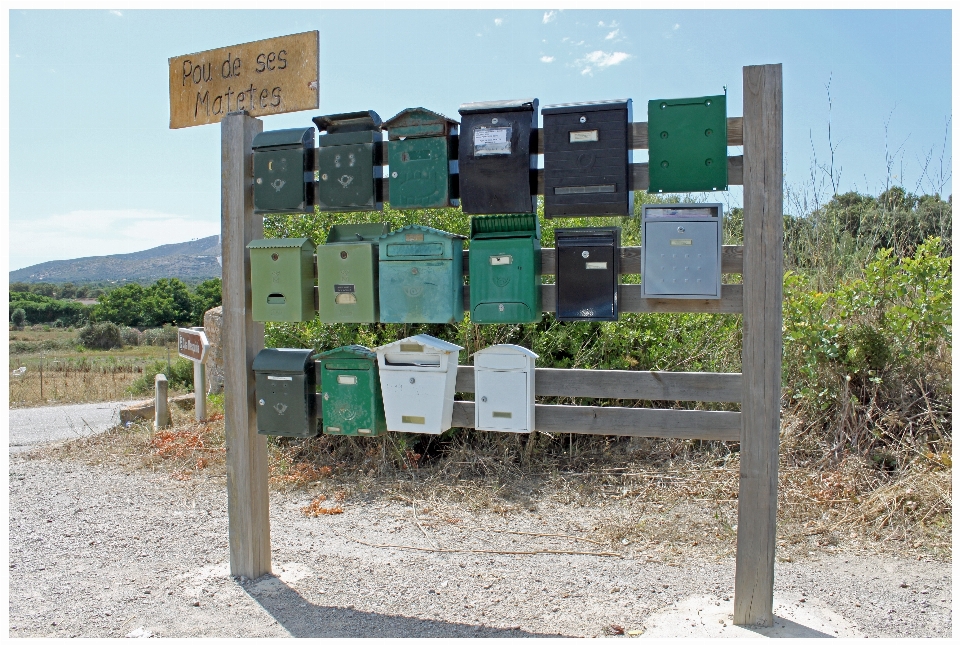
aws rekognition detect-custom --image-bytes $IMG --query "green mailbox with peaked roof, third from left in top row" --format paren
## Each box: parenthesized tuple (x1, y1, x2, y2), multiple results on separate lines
(383, 108, 459, 208)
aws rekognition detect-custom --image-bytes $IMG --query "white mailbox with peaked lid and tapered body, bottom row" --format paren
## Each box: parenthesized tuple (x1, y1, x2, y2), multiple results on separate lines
(375, 334, 463, 434)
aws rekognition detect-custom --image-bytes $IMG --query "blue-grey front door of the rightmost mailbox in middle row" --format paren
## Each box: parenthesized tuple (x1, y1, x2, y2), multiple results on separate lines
(642, 221, 720, 298)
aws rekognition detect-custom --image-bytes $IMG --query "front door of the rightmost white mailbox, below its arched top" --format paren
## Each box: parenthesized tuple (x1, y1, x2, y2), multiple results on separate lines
(474, 369, 530, 432)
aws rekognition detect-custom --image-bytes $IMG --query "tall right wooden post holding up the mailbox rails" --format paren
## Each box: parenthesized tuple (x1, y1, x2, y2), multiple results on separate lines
(733, 64, 783, 626)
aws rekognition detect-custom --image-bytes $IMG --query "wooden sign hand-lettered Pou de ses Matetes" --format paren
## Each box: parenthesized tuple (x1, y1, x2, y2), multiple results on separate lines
(170, 31, 320, 129)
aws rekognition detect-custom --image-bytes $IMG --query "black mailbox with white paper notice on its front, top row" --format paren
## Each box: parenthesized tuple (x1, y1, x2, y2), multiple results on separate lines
(457, 99, 539, 214)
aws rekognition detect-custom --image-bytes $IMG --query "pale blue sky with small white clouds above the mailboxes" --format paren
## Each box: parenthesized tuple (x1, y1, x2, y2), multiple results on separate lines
(9, 9, 952, 269)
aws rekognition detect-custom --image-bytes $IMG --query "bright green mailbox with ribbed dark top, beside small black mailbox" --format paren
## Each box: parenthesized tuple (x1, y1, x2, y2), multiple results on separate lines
(470, 213, 543, 324)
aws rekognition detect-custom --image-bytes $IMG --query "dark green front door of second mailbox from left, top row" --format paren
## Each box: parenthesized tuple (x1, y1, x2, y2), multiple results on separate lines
(317, 143, 377, 211)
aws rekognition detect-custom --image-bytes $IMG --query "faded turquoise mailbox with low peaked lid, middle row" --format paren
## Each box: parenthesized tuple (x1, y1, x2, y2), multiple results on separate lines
(380, 224, 466, 323)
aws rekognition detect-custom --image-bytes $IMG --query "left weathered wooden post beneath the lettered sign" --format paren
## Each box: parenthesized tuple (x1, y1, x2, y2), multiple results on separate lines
(220, 112, 270, 578)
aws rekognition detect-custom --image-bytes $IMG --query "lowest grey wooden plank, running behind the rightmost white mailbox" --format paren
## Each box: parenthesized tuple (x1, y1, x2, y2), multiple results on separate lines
(453, 401, 740, 441)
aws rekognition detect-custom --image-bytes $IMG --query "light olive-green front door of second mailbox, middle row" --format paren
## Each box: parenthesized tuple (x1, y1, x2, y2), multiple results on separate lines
(317, 243, 378, 323)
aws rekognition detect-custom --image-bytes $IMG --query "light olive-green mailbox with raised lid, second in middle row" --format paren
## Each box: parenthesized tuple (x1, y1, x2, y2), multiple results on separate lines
(317, 222, 390, 323)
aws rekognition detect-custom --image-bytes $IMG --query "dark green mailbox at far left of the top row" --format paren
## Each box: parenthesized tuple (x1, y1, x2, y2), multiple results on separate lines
(252, 126, 316, 213)
